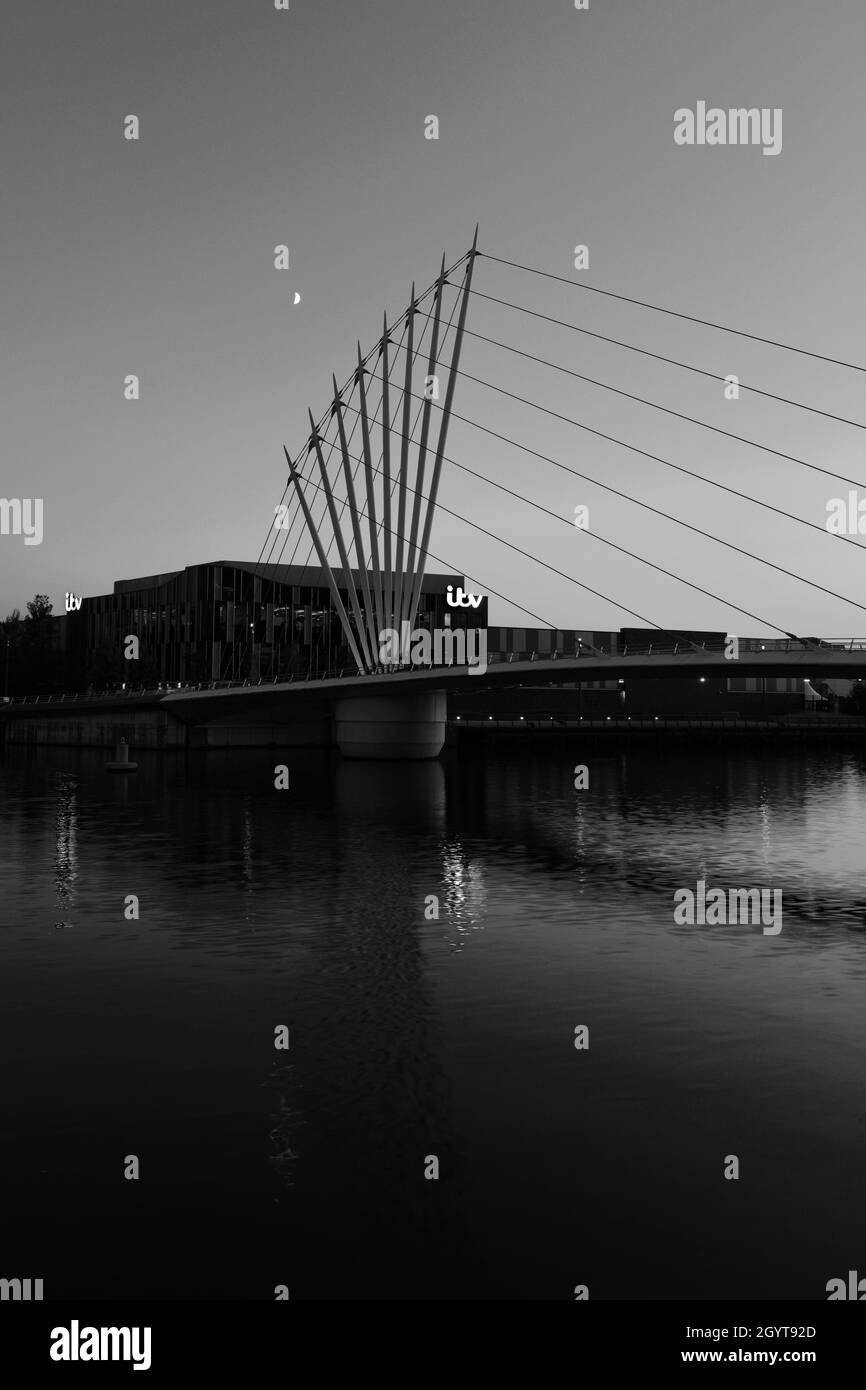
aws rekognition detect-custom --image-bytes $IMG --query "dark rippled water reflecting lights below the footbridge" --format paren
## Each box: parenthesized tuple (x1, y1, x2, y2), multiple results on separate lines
(0, 748, 866, 1300)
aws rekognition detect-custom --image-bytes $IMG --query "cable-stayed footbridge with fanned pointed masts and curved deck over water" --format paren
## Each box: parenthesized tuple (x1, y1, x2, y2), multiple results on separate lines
(154, 229, 866, 756)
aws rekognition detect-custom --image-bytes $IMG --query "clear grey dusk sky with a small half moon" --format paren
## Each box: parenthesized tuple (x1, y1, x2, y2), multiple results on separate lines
(0, 0, 866, 637)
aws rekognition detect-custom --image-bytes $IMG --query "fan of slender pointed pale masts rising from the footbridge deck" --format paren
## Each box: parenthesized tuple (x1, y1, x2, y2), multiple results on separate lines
(284, 228, 478, 671)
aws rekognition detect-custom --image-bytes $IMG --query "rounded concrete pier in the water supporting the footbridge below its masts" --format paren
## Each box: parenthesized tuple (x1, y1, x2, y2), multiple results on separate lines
(334, 691, 448, 759)
